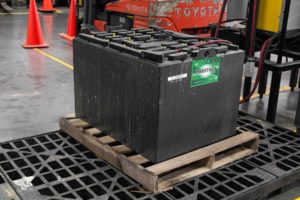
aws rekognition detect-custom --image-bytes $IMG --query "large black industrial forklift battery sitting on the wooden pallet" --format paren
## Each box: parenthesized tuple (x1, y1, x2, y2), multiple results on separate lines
(74, 27, 244, 163)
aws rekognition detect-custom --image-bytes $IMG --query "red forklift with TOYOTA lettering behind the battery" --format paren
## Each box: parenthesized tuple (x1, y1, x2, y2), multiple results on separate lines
(83, 0, 223, 35)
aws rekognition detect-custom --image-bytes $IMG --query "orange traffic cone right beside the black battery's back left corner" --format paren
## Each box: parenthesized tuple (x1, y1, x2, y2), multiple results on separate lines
(59, 0, 76, 41)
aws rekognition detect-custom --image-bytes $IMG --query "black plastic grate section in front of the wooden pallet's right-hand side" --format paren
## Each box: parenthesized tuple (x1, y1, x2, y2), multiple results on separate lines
(167, 160, 275, 200)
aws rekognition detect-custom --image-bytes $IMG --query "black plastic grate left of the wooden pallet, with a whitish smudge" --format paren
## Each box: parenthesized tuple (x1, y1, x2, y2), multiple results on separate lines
(0, 132, 171, 200)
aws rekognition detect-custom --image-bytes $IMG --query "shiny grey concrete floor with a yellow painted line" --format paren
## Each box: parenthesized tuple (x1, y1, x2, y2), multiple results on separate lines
(0, 5, 300, 200)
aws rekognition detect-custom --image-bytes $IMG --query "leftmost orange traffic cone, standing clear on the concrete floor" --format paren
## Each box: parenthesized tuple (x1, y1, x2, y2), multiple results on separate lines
(22, 0, 49, 48)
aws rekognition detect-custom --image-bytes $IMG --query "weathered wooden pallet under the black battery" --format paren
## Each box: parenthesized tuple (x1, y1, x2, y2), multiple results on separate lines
(59, 114, 259, 192)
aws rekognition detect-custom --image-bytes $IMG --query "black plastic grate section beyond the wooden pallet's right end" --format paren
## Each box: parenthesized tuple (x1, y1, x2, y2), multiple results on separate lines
(238, 113, 300, 176)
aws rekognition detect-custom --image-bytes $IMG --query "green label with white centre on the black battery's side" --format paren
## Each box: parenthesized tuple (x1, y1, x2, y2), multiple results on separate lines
(191, 56, 221, 87)
